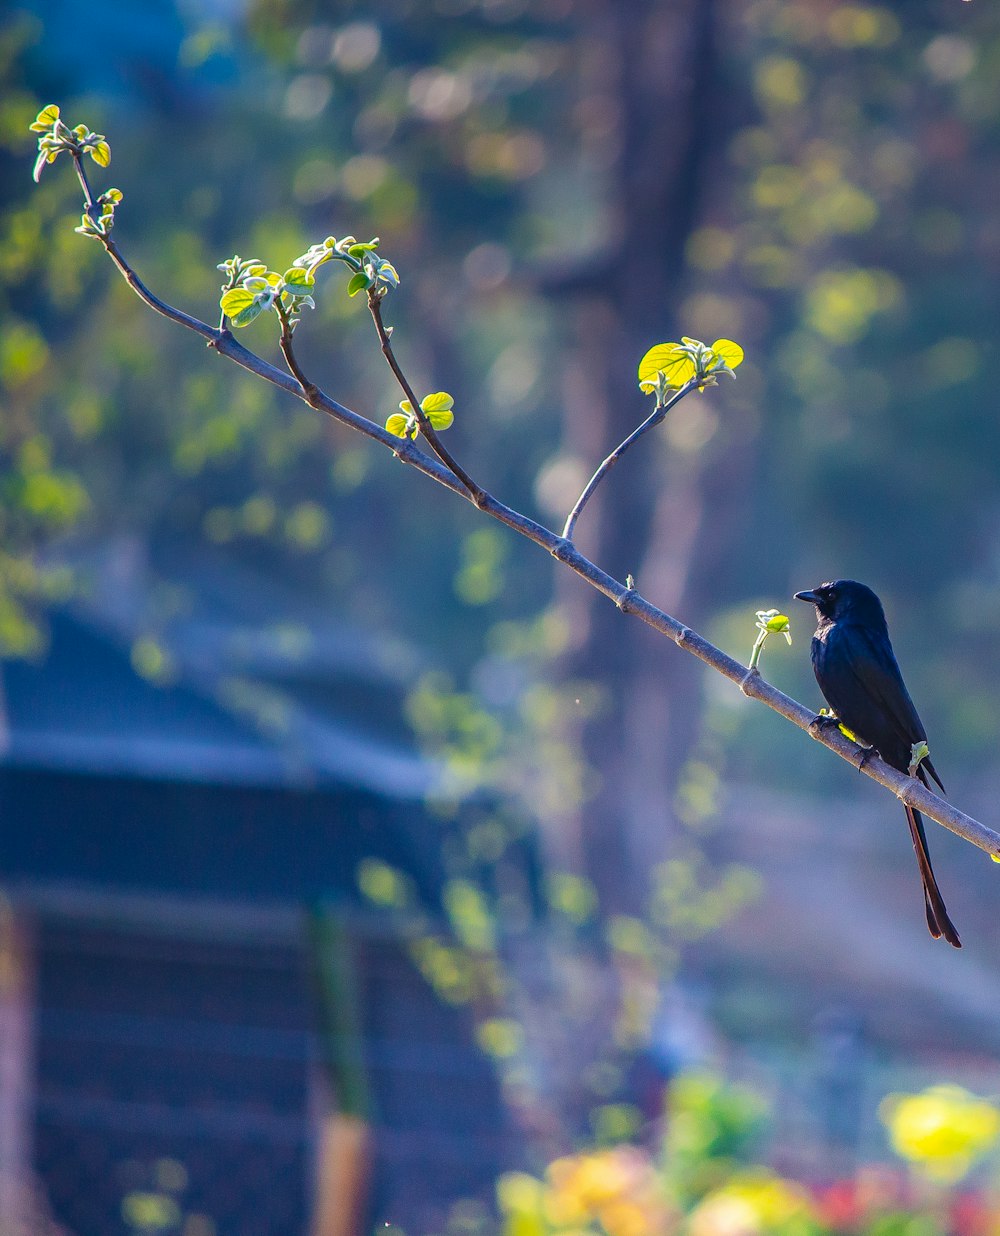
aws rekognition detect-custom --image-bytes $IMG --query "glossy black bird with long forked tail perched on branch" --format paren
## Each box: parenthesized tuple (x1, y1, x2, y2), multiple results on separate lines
(795, 580, 962, 948)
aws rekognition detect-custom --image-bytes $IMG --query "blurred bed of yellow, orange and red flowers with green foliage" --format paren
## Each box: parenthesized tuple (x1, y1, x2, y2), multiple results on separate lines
(494, 1074, 1000, 1236)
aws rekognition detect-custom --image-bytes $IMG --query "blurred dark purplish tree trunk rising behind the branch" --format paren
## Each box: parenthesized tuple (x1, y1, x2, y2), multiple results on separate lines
(556, 0, 719, 911)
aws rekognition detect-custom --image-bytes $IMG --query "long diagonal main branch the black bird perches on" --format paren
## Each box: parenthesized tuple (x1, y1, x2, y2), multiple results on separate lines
(70, 192, 1000, 858)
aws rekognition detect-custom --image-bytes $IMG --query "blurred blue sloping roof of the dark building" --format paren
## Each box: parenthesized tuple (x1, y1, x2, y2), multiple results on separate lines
(2, 545, 435, 800)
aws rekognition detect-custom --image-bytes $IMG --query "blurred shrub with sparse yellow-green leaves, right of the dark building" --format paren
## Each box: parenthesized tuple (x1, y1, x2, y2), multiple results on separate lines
(356, 830, 759, 1137)
